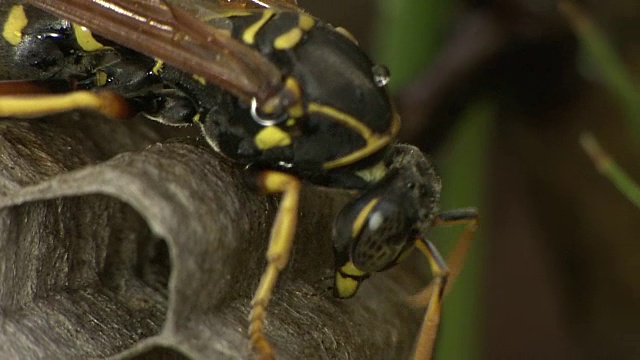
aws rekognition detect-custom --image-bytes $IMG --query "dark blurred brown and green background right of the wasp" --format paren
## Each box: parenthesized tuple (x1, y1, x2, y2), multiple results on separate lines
(300, 0, 640, 359)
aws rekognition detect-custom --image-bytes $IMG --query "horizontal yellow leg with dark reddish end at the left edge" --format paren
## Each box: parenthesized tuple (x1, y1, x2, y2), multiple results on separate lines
(0, 90, 135, 119)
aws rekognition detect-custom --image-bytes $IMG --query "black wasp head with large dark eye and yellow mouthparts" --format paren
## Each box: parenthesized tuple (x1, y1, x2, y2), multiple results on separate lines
(333, 145, 440, 298)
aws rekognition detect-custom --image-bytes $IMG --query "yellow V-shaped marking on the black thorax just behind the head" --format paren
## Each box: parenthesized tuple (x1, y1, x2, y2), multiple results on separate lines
(307, 102, 400, 169)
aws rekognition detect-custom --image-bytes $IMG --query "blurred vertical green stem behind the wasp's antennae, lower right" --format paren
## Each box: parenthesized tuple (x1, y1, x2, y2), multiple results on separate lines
(432, 101, 494, 359)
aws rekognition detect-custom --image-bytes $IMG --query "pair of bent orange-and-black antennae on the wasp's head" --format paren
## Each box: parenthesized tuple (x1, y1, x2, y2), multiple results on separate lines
(410, 209, 479, 360)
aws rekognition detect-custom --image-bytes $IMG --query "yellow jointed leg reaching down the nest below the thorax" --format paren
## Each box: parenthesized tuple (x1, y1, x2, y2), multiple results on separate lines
(249, 170, 300, 359)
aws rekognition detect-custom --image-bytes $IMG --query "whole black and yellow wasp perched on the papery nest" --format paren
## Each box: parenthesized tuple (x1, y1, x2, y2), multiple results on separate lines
(0, 0, 477, 358)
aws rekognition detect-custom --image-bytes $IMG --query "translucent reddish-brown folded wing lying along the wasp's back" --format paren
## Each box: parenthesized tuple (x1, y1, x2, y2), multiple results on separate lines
(27, 0, 283, 102)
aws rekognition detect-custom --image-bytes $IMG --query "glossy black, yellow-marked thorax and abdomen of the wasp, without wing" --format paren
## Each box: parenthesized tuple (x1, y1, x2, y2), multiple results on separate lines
(0, 1, 399, 188)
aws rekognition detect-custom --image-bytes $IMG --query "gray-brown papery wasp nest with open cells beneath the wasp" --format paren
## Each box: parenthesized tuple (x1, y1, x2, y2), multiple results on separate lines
(0, 113, 424, 359)
